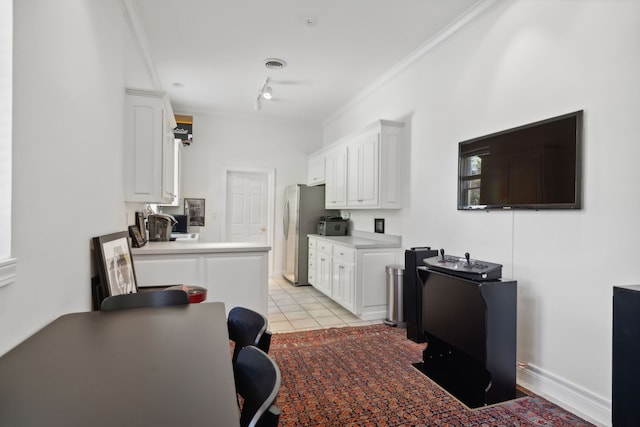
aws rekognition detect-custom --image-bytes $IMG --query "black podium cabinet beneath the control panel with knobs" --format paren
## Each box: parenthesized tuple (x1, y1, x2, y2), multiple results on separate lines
(418, 267, 517, 408)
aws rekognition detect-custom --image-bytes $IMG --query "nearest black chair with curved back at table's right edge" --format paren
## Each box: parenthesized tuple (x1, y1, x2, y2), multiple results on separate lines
(236, 346, 280, 427)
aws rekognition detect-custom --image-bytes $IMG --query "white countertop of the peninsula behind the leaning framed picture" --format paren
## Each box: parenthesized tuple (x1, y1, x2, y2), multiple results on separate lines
(131, 240, 271, 256)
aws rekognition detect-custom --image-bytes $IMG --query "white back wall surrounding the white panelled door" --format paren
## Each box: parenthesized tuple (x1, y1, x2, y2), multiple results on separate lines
(163, 113, 322, 275)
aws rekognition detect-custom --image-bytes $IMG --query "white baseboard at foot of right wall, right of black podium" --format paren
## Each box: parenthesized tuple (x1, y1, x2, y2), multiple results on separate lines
(517, 364, 611, 427)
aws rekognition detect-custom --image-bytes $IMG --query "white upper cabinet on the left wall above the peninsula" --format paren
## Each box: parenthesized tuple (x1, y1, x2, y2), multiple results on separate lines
(124, 89, 177, 203)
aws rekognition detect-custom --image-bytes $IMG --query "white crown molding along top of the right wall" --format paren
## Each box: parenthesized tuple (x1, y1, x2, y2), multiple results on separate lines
(322, 0, 507, 127)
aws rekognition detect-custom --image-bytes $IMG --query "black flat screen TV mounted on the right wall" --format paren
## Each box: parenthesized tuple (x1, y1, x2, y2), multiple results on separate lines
(458, 110, 583, 210)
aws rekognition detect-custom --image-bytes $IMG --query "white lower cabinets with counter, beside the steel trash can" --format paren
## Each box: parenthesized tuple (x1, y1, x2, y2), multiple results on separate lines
(309, 237, 397, 320)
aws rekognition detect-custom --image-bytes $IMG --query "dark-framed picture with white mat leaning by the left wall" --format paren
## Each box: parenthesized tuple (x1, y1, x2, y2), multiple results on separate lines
(93, 231, 138, 297)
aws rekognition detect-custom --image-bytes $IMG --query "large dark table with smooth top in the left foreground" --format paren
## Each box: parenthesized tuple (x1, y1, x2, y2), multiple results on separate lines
(0, 303, 239, 427)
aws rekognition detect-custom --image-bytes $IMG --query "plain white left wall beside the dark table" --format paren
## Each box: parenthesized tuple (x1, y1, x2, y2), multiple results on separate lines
(0, 0, 157, 354)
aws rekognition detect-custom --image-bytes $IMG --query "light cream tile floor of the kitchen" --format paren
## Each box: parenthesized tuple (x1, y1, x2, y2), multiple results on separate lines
(269, 278, 382, 333)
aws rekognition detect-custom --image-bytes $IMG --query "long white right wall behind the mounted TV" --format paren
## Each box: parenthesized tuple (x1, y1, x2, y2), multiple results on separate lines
(325, 0, 640, 424)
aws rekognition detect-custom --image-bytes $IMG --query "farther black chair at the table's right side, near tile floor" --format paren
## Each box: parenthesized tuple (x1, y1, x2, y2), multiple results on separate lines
(227, 307, 271, 365)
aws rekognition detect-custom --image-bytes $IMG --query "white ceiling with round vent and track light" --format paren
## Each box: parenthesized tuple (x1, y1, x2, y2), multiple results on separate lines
(133, 0, 481, 122)
